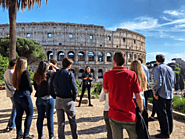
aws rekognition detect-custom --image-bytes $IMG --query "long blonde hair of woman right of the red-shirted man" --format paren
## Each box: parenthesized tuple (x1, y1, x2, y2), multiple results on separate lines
(130, 60, 147, 91)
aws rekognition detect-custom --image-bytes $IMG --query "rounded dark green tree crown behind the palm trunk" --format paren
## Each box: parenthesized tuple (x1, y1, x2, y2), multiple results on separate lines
(0, 36, 47, 64)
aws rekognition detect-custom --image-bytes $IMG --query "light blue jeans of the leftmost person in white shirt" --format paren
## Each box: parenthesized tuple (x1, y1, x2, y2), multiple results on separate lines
(7, 97, 16, 129)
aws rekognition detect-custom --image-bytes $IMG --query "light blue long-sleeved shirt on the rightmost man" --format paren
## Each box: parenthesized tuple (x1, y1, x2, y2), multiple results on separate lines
(153, 63, 176, 99)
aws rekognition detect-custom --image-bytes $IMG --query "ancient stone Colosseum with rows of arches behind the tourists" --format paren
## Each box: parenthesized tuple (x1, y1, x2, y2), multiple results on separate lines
(0, 22, 146, 81)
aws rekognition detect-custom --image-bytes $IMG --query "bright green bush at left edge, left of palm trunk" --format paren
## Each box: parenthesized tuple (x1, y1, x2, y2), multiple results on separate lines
(0, 54, 9, 82)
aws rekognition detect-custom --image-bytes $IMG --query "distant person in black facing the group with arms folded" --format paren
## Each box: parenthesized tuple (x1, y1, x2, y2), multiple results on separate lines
(78, 66, 93, 107)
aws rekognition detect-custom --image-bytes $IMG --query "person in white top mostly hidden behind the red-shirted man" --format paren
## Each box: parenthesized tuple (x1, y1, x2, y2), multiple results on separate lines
(99, 88, 113, 139)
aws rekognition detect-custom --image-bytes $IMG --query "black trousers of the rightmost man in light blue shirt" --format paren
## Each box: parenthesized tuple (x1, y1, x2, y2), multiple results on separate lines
(156, 97, 173, 135)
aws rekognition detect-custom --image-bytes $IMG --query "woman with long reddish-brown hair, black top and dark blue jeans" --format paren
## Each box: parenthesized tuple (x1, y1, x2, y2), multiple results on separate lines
(12, 57, 34, 139)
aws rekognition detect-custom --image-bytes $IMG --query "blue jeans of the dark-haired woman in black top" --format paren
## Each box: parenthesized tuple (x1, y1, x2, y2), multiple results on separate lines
(36, 97, 55, 138)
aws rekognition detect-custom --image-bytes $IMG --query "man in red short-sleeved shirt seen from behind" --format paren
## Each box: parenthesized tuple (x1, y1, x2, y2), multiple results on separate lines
(103, 52, 143, 139)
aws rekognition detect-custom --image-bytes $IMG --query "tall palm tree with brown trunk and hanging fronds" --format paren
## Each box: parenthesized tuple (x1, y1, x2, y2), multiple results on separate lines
(0, 0, 47, 61)
